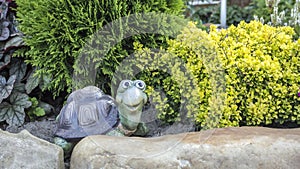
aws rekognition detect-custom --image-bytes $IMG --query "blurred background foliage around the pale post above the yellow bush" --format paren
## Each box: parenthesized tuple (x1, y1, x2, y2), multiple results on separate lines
(186, 0, 299, 32)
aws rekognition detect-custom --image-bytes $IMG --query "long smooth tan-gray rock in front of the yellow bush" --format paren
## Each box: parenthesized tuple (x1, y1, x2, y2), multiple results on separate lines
(71, 127, 300, 169)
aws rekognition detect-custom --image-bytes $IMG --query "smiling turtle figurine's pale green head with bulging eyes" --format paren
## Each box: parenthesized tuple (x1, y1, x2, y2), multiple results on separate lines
(116, 80, 147, 130)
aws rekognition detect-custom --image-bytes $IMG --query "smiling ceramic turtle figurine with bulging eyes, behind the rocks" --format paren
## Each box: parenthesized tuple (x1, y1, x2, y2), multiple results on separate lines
(54, 80, 149, 152)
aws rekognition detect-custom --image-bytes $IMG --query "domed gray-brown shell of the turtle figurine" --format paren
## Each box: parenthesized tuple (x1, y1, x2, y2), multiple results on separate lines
(55, 86, 119, 139)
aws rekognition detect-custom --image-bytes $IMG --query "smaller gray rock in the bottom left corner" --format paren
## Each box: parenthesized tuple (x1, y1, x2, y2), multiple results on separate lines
(0, 130, 64, 169)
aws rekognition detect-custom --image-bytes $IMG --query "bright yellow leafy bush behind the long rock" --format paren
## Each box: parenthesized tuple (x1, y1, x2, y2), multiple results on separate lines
(139, 21, 300, 128)
